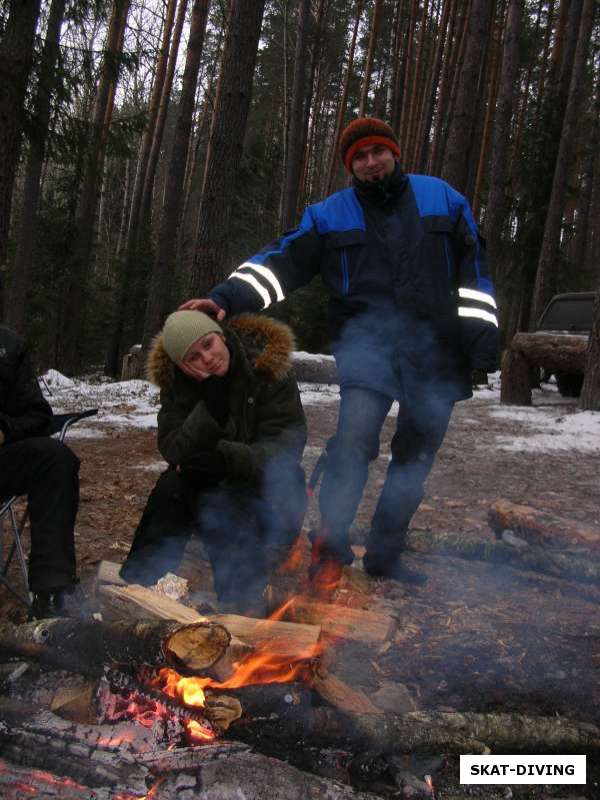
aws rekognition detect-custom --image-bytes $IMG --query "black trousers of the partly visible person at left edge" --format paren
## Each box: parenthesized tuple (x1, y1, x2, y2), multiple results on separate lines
(0, 437, 79, 592)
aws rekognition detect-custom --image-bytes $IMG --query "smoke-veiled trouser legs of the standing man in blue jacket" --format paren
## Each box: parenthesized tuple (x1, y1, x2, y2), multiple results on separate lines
(319, 388, 454, 563)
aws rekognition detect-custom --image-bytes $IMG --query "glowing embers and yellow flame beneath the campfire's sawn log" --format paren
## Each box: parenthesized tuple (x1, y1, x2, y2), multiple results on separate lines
(98, 669, 242, 747)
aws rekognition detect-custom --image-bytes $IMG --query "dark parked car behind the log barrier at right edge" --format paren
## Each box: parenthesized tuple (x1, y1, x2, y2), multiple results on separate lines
(536, 292, 595, 397)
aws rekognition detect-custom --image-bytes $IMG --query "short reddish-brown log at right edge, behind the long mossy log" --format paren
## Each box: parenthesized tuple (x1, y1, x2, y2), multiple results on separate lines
(488, 500, 600, 552)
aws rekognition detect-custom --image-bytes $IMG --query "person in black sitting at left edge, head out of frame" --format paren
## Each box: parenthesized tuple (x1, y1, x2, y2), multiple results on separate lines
(0, 327, 79, 619)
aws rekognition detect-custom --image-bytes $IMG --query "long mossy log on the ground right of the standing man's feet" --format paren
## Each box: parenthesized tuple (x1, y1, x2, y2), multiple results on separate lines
(408, 531, 600, 583)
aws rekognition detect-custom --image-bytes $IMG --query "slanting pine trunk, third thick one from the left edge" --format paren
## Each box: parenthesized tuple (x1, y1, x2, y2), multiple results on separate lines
(59, 0, 130, 374)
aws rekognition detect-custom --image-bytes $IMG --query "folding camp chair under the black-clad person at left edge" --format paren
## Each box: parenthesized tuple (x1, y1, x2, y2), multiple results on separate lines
(0, 408, 98, 606)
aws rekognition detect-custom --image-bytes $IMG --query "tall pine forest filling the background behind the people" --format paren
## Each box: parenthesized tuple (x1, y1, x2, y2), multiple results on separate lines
(0, 0, 600, 396)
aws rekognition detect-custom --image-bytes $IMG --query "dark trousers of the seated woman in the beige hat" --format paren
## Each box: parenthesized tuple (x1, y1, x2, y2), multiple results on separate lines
(120, 469, 302, 602)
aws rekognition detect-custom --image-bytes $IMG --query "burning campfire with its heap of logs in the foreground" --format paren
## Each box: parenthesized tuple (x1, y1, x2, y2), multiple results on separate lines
(0, 544, 600, 800)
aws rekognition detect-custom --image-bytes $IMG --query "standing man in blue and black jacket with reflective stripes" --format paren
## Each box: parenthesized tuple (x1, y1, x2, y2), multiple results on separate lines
(183, 117, 498, 582)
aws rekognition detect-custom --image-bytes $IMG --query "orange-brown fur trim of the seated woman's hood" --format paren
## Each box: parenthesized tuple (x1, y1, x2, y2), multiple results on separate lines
(146, 314, 296, 389)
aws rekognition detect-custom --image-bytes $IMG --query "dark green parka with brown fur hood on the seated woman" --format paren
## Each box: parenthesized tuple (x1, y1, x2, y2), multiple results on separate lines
(146, 314, 306, 485)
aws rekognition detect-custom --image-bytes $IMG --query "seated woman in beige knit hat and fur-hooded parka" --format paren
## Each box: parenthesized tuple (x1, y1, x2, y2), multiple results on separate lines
(121, 311, 306, 613)
